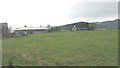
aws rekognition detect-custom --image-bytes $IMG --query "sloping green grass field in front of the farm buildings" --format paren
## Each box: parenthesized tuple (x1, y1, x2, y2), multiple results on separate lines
(2, 30, 118, 66)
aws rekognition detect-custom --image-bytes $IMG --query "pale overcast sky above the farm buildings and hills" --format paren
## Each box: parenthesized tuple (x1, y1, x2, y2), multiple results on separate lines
(0, 0, 118, 28)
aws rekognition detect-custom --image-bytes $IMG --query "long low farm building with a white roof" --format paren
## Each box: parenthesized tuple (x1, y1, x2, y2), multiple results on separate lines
(14, 27, 48, 35)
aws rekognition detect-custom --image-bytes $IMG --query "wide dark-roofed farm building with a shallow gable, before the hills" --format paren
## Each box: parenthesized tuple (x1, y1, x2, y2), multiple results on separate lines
(51, 22, 94, 31)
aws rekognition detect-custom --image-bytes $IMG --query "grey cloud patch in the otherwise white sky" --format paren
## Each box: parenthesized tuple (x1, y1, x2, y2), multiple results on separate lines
(69, 2, 118, 18)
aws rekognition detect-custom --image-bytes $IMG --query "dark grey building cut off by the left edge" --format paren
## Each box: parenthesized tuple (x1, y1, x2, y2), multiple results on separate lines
(0, 23, 9, 37)
